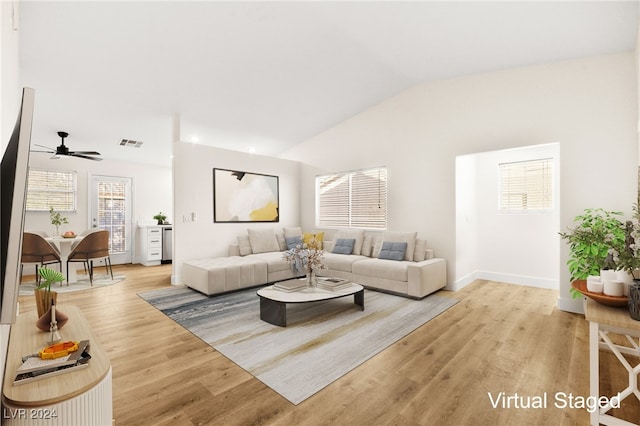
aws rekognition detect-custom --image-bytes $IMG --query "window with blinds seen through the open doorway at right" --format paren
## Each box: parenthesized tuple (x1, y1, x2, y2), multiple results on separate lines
(500, 158, 553, 213)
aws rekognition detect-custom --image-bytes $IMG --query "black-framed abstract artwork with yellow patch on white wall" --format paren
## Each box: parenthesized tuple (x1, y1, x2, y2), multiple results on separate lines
(213, 169, 280, 222)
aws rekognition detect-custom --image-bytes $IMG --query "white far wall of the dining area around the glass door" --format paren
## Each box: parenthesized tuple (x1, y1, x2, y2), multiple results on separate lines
(24, 153, 173, 274)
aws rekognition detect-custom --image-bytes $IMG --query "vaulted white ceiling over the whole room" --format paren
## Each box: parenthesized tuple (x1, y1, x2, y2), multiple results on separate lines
(19, 1, 638, 165)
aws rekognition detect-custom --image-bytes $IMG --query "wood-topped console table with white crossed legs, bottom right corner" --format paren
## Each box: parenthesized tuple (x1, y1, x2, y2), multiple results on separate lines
(584, 298, 640, 425)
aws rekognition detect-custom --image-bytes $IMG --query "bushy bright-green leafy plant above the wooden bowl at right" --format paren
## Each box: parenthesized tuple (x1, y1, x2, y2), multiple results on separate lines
(560, 208, 625, 281)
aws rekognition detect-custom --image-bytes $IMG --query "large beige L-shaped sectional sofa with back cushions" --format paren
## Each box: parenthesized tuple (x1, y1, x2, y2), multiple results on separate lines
(182, 228, 447, 299)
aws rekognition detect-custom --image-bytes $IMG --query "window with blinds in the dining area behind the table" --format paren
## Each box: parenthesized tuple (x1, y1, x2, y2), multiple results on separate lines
(26, 169, 77, 212)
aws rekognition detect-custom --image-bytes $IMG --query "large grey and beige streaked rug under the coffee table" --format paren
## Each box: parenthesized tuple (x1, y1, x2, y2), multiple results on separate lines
(139, 286, 457, 404)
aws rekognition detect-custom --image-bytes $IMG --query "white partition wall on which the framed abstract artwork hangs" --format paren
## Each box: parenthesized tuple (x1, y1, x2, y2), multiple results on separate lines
(173, 142, 300, 284)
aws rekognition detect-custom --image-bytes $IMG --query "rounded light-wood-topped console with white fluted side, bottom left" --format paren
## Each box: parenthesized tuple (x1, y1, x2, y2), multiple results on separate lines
(2, 305, 113, 426)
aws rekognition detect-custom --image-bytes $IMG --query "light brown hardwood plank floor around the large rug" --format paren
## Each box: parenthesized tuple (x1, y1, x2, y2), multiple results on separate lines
(13, 265, 640, 425)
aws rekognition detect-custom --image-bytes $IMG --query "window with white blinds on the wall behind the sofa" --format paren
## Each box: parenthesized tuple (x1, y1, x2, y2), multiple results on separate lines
(316, 167, 387, 229)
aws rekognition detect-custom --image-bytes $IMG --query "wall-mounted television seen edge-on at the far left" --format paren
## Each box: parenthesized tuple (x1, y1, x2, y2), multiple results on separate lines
(0, 88, 34, 324)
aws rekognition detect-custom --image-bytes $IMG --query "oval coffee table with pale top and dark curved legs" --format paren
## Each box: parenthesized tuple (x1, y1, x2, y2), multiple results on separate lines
(258, 283, 364, 327)
